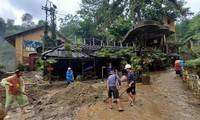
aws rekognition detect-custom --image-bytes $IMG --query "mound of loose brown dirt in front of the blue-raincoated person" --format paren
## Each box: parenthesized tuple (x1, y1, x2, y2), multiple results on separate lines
(31, 82, 102, 120)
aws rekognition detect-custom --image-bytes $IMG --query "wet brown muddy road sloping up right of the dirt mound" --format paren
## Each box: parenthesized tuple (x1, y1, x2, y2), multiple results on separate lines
(75, 72, 200, 120)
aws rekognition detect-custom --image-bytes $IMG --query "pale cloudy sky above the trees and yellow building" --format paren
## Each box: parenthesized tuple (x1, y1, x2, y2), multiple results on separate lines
(0, 0, 200, 24)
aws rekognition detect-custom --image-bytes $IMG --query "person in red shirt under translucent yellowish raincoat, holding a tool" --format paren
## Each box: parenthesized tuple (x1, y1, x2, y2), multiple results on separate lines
(1, 69, 29, 118)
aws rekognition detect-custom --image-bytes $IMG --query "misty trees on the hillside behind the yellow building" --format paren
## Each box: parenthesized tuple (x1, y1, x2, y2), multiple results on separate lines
(0, 13, 42, 71)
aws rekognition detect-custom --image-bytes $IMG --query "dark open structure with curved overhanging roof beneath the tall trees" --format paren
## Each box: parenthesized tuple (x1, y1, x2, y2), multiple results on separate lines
(123, 15, 178, 70)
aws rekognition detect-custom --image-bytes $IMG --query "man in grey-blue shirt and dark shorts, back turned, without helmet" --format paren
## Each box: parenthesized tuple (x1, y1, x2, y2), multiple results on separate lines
(107, 70, 124, 112)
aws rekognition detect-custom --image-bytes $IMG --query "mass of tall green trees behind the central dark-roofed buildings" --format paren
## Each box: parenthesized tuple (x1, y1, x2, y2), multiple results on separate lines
(57, 0, 189, 44)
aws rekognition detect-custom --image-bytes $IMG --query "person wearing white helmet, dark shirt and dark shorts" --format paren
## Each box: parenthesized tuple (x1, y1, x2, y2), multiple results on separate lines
(124, 64, 136, 106)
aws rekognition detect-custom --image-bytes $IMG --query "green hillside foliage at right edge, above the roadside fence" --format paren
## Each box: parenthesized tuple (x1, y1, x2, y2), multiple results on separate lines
(176, 13, 200, 69)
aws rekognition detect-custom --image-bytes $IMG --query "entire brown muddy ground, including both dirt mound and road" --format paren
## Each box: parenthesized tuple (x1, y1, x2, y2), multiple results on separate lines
(1, 71, 200, 120)
